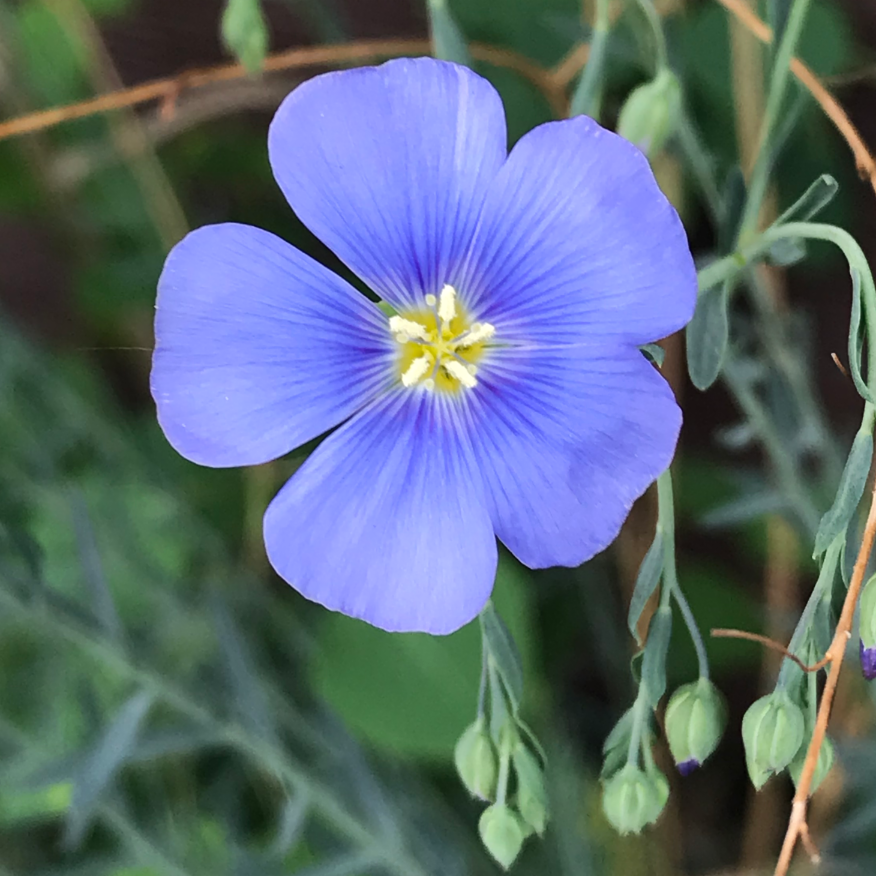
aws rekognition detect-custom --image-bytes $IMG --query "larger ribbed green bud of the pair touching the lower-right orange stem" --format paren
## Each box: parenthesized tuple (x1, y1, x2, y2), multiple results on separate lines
(742, 690, 806, 790)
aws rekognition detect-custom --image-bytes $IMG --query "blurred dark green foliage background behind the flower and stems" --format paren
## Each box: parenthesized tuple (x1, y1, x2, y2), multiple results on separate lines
(0, 0, 876, 876)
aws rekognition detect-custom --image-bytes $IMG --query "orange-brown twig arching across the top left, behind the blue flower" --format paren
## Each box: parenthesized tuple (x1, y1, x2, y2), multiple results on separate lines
(0, 39, 565, 140)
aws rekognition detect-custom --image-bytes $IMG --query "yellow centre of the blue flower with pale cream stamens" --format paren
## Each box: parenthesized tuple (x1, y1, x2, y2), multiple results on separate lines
(389, 286, 496, 392)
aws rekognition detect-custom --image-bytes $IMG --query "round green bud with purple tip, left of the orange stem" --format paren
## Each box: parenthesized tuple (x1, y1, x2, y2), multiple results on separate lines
(666, 678, 727, 776)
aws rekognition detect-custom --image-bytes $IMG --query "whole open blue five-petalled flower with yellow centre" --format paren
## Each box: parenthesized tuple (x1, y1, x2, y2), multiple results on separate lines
(152, 59, 696, 633)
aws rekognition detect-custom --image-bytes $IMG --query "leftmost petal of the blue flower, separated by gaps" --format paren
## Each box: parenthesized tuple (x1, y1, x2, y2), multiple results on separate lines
(151, 224, 394, 468)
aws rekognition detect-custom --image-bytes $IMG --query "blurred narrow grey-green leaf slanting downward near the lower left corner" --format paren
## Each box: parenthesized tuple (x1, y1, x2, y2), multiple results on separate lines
(63, 691, 152, 849)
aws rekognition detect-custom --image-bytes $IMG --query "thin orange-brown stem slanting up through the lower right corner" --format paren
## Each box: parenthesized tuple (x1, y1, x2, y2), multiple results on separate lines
(772, 486, 876, 876)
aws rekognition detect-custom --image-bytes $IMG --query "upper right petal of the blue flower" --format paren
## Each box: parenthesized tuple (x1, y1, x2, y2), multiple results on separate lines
(458, 116, 697, 344)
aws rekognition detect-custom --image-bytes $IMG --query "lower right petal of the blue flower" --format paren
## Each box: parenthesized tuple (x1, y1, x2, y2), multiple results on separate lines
(471, 347, 681, 568)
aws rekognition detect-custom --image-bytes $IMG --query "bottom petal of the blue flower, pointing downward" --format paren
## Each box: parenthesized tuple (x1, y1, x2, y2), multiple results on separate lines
(265, 390, 497, 634)
